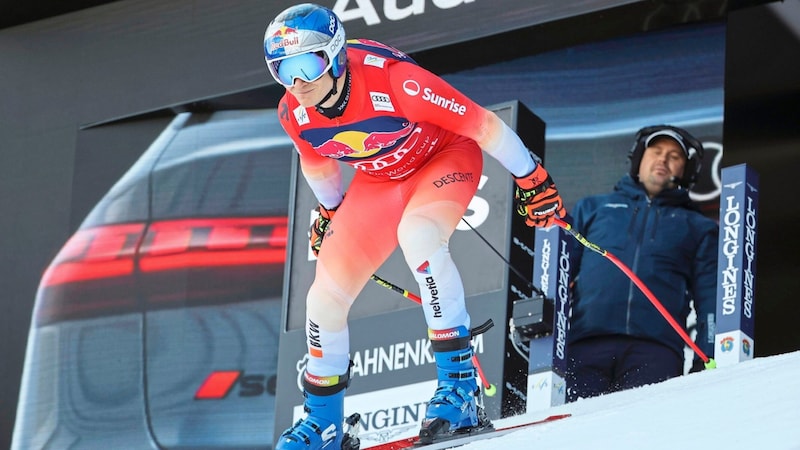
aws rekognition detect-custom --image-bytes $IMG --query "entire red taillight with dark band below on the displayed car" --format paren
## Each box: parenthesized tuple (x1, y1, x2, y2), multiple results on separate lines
(36, 217, 287, 326)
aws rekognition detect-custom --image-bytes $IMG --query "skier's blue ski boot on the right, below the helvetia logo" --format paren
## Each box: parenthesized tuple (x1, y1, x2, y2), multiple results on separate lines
(419, 326, 491, 444)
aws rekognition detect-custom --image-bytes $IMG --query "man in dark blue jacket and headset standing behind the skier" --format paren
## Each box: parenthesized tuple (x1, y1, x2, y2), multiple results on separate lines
(567, 125, 718, 401)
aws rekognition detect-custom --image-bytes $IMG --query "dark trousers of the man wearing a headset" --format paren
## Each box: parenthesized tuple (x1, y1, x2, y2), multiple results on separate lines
(566, 336, 683, 402)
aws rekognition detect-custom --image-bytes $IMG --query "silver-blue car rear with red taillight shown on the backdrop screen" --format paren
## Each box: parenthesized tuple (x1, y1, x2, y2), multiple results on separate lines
(12, 110, 294, 450)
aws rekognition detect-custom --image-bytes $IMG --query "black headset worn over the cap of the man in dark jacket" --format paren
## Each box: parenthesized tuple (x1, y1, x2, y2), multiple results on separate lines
(628, 125, 705, 190)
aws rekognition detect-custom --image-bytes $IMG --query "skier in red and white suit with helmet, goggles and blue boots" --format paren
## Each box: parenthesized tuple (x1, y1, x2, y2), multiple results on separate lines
(264, 3, 565, 450)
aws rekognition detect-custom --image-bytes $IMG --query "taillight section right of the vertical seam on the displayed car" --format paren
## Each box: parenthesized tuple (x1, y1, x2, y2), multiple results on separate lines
(139, 217, 288, 309)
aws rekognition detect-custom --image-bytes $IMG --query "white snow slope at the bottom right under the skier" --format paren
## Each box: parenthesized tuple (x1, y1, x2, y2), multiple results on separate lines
(450, 352, 800, 450)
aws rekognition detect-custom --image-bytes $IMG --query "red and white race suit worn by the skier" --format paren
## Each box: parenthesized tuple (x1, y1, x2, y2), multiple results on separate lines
(279, 36, 564, 366)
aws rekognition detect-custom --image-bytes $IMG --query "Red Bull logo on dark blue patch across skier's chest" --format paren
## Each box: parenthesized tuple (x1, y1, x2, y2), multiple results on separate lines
(301, 117, 415, 161)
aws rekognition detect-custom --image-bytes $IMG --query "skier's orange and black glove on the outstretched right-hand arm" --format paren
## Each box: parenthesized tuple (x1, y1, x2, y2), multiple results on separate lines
(514, 164, 566, 227)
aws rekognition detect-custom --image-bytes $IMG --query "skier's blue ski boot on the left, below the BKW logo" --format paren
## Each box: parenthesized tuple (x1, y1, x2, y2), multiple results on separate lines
(275, 371, 358, 450)
